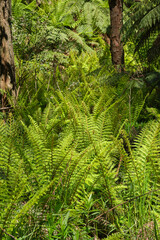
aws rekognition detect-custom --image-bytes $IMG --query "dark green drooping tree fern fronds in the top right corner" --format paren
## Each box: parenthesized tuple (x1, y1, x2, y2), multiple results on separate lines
(124, 1, 160, 63)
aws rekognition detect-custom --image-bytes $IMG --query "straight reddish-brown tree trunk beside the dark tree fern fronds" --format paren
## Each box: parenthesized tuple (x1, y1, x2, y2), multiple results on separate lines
(109, 0, 124, 72)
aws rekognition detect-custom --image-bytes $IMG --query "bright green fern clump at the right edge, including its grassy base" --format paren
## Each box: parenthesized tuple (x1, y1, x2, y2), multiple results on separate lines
(116, 121, 160, 238)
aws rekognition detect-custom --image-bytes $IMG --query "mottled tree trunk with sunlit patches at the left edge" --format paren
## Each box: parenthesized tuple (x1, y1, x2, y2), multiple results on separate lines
(0, 0, 15, 105)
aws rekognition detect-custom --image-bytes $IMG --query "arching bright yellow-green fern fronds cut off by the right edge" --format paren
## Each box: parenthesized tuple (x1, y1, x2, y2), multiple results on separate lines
(120, 121, 160, 206)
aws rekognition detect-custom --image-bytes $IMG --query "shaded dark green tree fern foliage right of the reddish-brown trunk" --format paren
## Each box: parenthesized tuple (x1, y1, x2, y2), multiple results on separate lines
(124, 0, 160, 69)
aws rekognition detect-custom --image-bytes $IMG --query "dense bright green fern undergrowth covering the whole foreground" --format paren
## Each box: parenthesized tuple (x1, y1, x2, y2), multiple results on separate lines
(0, 70, 160, 240)
